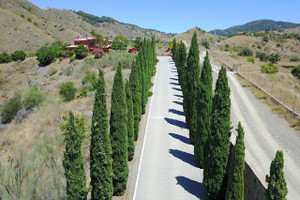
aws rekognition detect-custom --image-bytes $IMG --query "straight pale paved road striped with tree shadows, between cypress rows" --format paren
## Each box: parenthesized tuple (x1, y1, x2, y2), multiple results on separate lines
(133, 56, 207, 200)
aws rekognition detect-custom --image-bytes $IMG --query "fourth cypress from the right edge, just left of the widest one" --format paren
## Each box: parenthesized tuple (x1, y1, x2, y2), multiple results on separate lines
(194, 52, 213, 168)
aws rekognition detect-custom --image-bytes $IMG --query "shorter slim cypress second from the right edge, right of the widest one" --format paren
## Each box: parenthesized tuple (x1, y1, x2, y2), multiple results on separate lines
(225, 122, 245, 200)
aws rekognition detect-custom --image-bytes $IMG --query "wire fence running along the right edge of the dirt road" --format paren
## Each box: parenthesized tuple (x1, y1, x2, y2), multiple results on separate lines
(212, 58, 300, 117)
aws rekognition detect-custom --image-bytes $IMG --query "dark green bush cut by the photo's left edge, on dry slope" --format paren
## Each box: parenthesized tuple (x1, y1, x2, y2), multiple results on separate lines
(1, 93, 22, 123)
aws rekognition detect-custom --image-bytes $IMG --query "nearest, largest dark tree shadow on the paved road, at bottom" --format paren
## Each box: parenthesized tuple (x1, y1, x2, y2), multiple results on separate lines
(176, 176, 208, 200)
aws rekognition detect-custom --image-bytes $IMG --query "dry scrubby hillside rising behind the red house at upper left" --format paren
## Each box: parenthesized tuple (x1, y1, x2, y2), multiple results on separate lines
(0, 0, 172, 53)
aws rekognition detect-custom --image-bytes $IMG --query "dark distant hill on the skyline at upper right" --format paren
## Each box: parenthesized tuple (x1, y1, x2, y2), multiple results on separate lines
(209, 20, 300, 36)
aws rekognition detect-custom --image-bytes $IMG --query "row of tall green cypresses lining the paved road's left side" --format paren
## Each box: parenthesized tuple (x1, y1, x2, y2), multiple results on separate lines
(62, 38, 156, 200)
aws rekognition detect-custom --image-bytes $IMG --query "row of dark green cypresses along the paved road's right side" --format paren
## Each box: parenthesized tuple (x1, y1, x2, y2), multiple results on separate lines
(172, 32, 287, 200)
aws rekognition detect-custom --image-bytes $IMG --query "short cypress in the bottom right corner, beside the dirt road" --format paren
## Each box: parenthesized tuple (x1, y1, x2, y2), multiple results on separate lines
(265, 151, 288, 200)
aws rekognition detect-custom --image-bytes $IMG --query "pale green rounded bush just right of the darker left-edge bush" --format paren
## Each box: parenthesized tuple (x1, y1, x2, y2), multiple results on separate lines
(23, 85, 46, 109)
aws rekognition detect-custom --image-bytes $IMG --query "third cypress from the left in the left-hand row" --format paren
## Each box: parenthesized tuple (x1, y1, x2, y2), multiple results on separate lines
(110, 63, 128, 195)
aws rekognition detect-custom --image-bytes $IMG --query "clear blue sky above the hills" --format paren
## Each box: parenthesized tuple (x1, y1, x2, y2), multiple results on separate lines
(29, 0, 300, 33)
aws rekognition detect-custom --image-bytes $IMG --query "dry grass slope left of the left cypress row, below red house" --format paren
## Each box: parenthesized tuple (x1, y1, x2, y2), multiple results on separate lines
(0, 53, 131, 199)
